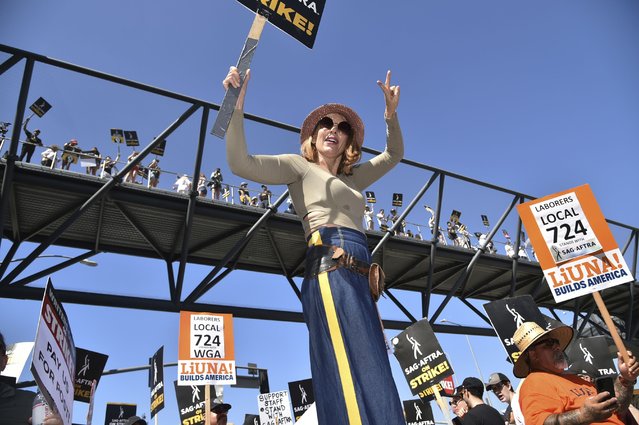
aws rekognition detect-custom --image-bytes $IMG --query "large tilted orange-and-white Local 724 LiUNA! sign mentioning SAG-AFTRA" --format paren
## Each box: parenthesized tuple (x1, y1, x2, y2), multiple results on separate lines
(517, 184, 634, 303)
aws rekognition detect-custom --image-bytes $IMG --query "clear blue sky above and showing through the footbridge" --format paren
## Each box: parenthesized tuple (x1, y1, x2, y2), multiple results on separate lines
(0, 0, 639, 423)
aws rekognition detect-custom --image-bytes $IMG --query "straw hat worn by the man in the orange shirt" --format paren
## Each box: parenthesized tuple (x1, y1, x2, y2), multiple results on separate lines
(513, 322, 574, 378)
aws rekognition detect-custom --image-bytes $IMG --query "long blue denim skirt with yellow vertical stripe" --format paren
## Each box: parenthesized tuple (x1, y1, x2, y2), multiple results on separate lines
(302, 227, 405, 425)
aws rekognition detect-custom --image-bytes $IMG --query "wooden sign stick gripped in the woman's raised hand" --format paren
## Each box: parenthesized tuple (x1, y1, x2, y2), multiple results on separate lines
(211, 13, 266, 139)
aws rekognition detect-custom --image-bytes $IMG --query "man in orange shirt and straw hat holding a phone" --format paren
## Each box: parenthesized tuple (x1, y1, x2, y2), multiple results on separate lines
(513, 322, 639, 425)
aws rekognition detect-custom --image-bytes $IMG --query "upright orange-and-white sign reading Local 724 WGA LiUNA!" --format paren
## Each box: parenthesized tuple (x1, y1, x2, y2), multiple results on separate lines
(178, 311, 236, 385)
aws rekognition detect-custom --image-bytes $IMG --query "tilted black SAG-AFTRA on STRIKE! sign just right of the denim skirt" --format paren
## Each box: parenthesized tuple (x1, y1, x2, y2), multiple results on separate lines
(391, 319, 454, 399)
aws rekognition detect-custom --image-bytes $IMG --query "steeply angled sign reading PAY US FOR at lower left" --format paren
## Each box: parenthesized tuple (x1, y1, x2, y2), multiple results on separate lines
(31, 278, 75, 425)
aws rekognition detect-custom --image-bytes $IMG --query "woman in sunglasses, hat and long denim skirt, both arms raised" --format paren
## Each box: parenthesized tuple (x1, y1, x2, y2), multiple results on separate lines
(223, 67, 404, 425)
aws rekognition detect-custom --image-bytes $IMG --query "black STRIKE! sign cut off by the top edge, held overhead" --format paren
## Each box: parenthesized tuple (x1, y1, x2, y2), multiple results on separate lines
(238, 0, 326, 49)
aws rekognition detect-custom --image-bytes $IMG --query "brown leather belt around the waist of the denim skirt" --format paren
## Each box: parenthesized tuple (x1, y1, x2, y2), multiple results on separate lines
(304, 245, 371, 278)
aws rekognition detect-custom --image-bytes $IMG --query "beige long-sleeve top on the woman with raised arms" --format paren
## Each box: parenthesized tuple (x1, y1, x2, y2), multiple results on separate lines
(226, 109, 404, 235)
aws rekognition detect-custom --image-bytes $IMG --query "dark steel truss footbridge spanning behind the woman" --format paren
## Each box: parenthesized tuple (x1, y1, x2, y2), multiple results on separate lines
(0, 45, 639, 341)
